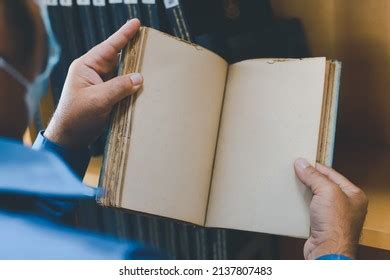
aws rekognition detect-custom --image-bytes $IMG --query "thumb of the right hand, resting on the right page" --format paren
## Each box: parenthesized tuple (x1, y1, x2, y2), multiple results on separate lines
(294, 158, 334, 195)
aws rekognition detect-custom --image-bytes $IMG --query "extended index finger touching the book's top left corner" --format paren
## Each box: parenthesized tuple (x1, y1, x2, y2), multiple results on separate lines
(81, 19, 140, 74)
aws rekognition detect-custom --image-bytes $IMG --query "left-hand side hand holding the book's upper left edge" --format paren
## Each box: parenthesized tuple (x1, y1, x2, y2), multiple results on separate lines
(45, 19, 143, 148)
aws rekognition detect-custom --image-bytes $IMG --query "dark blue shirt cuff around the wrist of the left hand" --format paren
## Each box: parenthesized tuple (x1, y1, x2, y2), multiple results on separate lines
(32, 131, 91, 179)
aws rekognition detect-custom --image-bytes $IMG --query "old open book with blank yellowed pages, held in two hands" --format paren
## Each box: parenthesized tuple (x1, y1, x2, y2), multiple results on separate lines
(99, 28, 340, 237)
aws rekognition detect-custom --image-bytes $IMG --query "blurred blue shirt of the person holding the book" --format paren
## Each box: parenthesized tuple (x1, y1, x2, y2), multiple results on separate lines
(0, 133, 160, 259)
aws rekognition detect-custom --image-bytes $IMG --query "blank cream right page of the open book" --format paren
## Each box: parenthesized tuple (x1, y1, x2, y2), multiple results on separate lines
(206, 58, 326, 237)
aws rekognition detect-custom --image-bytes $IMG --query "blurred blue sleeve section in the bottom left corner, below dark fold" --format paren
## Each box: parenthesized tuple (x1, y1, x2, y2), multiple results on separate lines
(0, 211, 166, 260)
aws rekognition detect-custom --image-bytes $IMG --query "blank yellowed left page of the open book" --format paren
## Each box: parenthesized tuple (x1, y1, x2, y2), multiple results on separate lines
(121, 29, 228, 225)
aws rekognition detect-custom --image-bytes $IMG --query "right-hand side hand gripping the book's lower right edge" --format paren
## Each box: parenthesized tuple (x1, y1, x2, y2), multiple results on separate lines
(295, 159, 368, 259)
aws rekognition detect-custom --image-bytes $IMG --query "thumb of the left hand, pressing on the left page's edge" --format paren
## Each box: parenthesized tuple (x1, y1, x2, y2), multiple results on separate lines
(91, 73, 143, 110)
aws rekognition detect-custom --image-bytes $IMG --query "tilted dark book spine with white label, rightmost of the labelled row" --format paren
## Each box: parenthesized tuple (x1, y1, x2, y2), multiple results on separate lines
(164, 0, 193, 42)
